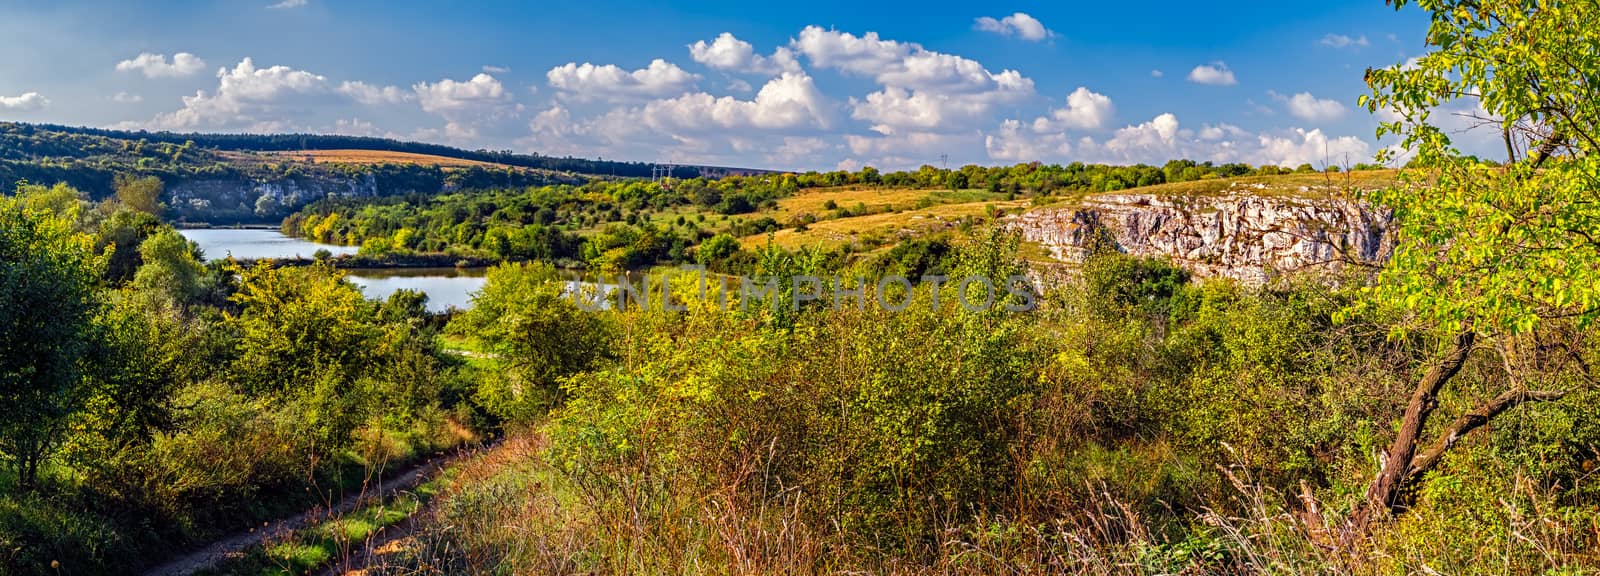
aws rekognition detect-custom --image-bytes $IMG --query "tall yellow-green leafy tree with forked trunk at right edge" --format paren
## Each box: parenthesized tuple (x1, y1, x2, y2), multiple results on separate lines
(1352, 0, 1600, 528)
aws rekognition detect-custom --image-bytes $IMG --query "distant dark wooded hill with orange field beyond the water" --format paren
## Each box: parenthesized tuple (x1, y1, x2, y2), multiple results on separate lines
(0, 122, 765, 222)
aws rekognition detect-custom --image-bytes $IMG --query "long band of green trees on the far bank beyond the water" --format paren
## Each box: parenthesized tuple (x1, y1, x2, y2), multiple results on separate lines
(282, 160, 1356, 270)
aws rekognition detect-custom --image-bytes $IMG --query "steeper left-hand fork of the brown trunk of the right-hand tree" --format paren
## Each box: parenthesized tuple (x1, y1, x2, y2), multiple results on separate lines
(1350, 330, 1477, 531)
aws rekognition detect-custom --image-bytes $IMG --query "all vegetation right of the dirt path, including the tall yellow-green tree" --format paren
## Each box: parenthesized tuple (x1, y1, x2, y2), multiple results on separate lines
(305, 0, 1600, 574)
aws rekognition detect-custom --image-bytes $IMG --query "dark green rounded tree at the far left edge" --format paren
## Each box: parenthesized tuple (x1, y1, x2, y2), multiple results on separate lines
(0, 198, 102, 486)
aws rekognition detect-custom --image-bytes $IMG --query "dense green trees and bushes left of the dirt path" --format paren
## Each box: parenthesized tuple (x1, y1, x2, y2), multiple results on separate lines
(0, 179, 485, 574)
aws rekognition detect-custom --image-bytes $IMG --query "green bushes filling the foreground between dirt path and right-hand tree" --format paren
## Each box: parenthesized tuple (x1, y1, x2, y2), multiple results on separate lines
(393, 235, 1600, 574)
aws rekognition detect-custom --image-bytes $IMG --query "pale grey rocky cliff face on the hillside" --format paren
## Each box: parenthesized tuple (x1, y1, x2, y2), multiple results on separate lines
(1011, 184, 1392, 283)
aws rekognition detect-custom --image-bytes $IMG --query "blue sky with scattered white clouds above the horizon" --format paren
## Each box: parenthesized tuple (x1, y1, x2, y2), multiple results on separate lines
(0, 0, 1452, 170)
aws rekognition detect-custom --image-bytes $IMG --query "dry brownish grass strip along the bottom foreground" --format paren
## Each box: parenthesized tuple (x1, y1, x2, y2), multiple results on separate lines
(368, 434, 1595, 576)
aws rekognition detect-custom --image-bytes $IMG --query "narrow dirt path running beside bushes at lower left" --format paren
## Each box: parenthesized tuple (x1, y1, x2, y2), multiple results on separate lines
(144, 448, 482, 576)
